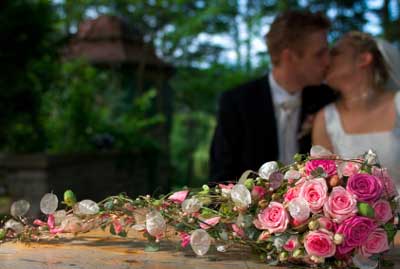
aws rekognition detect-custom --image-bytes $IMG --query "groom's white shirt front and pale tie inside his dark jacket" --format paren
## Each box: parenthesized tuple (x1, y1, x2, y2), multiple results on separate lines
(269, 72, 301, 164)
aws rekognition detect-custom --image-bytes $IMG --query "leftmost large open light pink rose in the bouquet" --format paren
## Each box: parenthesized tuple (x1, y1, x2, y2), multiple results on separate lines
(253, 202, 289, 233)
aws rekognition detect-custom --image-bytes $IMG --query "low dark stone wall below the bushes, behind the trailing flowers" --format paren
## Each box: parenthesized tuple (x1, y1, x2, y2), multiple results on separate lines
(0, 152, 169, 216)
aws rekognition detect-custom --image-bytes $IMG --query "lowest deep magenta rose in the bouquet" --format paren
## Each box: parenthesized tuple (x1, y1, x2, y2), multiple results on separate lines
(336, 216, 377, 254)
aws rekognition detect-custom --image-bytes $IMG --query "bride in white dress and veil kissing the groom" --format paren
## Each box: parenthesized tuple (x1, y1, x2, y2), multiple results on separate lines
(312, 32, 400, 189)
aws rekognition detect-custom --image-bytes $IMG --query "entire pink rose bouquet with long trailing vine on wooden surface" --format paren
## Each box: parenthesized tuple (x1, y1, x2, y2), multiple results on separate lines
(0, 146, 399, 269)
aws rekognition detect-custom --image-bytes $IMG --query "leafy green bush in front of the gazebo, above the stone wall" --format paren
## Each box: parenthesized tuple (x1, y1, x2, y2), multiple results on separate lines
(41, 61, 163, 153)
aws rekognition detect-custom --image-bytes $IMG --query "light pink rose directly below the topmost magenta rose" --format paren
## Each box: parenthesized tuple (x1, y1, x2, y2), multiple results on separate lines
(299, 178, 328, 214)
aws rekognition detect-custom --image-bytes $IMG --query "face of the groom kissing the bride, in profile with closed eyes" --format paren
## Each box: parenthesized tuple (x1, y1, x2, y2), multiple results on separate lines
(296, 30, 330, 87)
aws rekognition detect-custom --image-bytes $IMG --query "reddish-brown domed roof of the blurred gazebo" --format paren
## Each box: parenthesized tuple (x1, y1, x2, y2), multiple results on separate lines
(64, 15, 172, 71)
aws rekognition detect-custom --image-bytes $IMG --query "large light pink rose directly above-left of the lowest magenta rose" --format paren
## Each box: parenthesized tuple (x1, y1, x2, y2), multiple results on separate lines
(324, 186, 357, 223)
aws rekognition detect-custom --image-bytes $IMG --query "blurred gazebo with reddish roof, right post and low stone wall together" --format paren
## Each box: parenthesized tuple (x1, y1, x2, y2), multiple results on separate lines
(0, 16, 174, 215)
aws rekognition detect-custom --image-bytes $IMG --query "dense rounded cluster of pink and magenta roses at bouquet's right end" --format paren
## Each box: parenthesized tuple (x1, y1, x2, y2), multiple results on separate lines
(253, 155, 398, 266)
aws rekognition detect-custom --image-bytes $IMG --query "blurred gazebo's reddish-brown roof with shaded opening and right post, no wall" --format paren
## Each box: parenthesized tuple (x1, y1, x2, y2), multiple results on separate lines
(63, 15, 174, 151)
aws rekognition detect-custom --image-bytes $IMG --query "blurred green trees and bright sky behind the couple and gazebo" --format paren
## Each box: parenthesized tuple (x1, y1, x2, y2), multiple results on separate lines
(0, 0, 400, 193)
